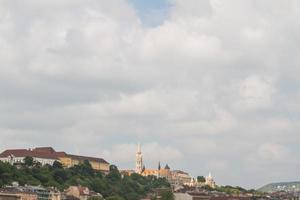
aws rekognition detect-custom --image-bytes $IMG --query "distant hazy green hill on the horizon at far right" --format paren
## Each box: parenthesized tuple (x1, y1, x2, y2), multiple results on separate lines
(258, 181, 300, 192)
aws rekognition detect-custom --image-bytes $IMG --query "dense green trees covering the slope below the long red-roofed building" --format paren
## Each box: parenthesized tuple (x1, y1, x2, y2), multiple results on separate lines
(0, 158, 170, 200)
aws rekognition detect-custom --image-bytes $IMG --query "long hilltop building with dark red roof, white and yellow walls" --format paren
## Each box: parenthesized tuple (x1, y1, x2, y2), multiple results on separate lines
(0, 147, 109, 173)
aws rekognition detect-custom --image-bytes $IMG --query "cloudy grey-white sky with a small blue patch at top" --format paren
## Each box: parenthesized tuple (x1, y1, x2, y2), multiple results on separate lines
(0, 0, 300, 188)
